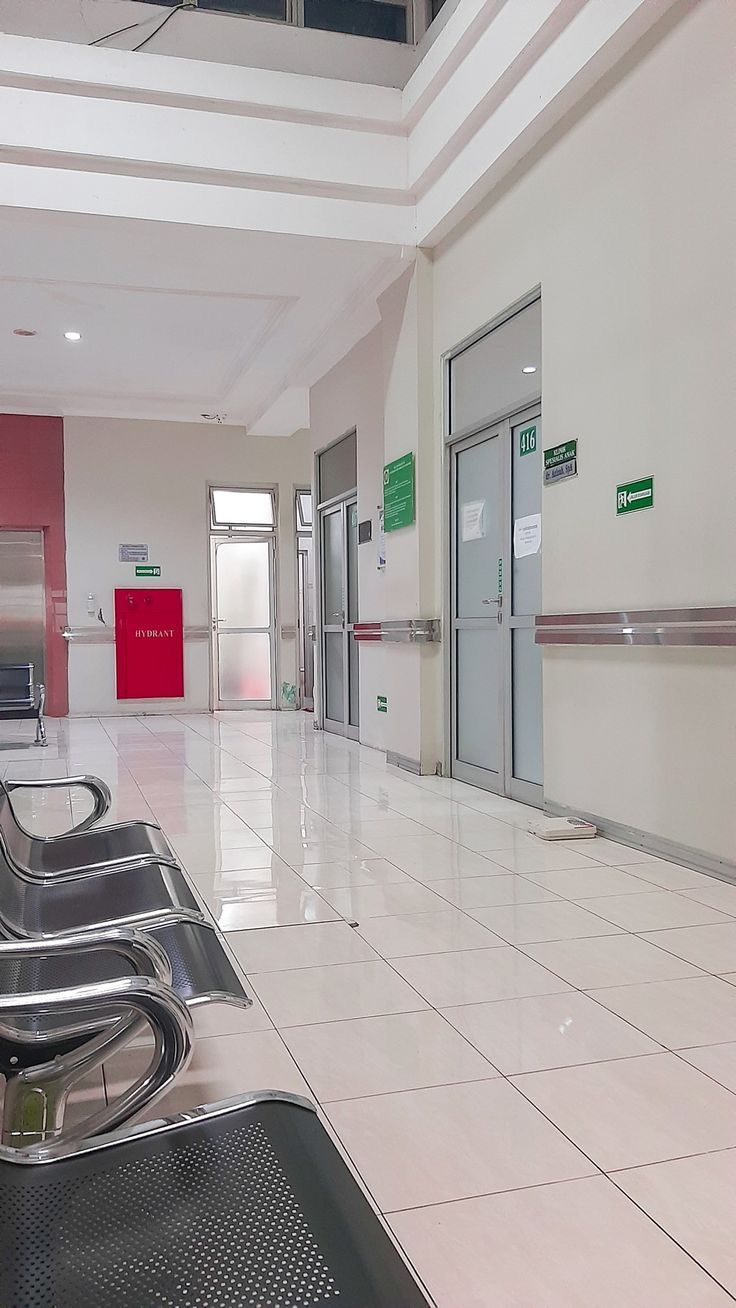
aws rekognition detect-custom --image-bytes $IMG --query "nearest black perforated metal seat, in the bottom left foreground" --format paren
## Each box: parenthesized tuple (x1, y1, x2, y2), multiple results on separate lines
(0, 1093, 430, 1308)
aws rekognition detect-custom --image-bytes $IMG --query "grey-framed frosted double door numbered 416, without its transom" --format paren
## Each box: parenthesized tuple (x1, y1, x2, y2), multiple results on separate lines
(450, 407, 543, 804)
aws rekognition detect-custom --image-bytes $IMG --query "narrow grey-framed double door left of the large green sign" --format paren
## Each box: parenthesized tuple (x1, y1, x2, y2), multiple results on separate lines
(320, 500, 360, 739)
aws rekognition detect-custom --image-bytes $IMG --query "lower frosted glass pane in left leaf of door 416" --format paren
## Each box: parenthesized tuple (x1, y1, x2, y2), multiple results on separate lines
(455, 628, 501, 772)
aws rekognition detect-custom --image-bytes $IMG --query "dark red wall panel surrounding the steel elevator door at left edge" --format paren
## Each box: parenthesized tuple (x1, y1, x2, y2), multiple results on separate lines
(0, 413, 69, 718)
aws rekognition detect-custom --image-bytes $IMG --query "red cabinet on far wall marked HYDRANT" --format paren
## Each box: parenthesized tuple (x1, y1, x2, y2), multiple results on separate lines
(115, 587, 184, 700)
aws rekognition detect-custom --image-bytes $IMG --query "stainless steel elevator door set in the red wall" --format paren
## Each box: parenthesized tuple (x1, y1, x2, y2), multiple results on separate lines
(0, 531, 46, 685)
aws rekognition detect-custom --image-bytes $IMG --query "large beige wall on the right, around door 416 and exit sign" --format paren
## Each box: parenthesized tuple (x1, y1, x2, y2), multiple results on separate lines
(434, 0, 736, 859)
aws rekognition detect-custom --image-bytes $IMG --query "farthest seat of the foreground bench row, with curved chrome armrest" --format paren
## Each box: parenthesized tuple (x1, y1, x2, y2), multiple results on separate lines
(0, 777, 178, 880)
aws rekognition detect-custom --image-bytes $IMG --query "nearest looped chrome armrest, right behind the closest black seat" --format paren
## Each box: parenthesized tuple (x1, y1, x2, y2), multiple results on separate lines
(0, 977, 193, 1159)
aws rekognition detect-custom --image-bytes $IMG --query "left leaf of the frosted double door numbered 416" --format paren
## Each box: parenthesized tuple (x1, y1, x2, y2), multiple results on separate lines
(451, 428, 505, 791)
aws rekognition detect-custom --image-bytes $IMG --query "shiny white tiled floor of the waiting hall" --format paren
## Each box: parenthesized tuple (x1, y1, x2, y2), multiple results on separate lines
(0, 713, 736, 1308)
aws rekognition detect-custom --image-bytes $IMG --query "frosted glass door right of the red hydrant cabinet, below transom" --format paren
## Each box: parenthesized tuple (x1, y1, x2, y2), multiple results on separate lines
(212, 538, 275, 709)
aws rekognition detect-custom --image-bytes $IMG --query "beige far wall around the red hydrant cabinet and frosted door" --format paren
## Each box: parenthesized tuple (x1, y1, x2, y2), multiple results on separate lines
(64, 419, 311, 713)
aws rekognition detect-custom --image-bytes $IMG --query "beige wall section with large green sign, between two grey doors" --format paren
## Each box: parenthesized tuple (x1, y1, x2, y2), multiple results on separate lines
(310, 254, 442, 772)
